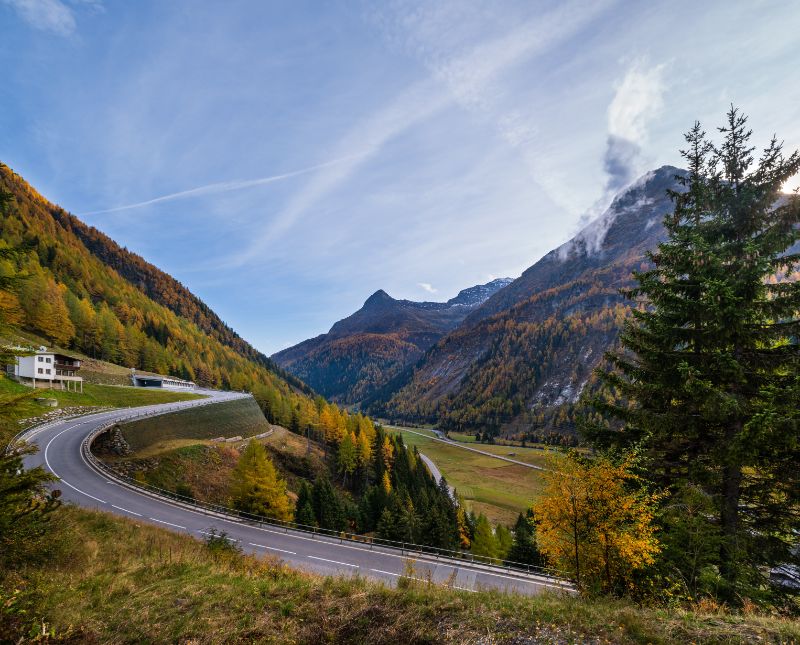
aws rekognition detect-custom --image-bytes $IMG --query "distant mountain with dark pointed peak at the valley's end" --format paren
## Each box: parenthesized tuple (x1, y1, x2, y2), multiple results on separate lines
(272, 278, 511, 403)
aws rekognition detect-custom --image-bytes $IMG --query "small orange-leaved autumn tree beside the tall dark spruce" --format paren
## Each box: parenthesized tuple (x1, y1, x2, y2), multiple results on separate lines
(533, 453, 660, 592)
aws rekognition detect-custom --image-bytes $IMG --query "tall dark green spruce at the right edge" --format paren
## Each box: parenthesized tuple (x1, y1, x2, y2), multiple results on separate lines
(587, 107, 800, 597)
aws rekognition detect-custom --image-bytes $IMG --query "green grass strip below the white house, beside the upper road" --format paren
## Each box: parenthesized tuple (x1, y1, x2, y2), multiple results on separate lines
(0, 375, 202, 443)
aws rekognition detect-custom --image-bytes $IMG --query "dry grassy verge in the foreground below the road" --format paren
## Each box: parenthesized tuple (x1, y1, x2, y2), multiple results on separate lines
(0, 507, 800, 645)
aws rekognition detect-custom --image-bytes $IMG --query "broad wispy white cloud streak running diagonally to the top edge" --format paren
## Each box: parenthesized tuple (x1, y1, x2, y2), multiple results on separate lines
(228, 0, 612, 268)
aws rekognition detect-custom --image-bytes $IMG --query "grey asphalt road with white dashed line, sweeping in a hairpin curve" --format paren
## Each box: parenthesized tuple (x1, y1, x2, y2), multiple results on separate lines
(24, 391, 569, 595)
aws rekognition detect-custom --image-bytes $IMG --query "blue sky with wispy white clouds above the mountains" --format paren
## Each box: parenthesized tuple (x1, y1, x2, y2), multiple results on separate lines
(0, 0, 800, 354)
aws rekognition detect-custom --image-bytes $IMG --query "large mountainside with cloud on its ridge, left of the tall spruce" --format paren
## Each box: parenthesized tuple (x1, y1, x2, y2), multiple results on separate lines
(367, 166, 681, 441)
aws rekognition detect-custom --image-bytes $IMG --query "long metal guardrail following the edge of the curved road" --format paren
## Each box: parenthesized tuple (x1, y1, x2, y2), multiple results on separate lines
(14, 397, 573, 590)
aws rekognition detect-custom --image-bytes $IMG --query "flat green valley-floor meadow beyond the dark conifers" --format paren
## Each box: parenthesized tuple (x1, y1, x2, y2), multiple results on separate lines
(387, 426, 544, 524)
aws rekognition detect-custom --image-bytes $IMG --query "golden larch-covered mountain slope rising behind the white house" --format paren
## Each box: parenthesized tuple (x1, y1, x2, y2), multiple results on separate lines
(0, 164, 316, 423)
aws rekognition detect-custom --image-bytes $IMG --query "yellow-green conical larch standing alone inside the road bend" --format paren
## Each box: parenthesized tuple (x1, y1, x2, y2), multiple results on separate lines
(231, 439, 292, 520)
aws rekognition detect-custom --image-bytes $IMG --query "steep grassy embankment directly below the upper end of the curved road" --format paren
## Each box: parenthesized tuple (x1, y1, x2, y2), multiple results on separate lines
(120, 398, 269, 456)
